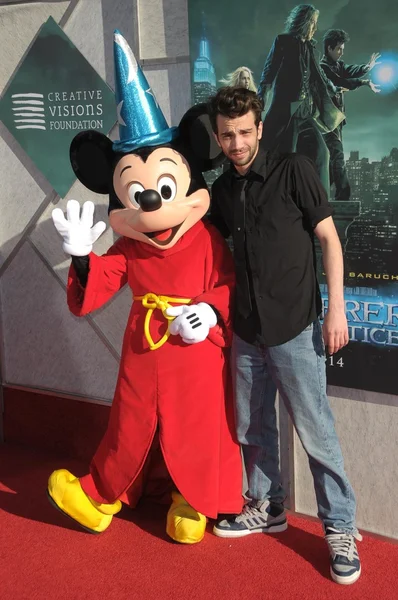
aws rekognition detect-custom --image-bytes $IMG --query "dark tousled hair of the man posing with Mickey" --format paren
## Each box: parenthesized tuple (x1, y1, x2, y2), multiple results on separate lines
(208, 87, 264, 133)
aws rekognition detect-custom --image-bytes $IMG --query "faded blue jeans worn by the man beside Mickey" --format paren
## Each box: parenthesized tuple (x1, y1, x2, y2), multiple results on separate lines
(232, 321, 357, 533)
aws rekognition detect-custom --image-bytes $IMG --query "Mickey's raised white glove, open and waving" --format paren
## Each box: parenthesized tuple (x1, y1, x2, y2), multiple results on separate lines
(52, 200, 106, 256)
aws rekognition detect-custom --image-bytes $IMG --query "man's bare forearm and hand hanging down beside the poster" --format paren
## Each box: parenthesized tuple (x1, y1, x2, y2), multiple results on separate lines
(314, 217, 348, 354)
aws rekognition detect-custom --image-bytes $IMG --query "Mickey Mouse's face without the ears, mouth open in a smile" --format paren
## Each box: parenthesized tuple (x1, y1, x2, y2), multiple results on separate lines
(109, 147, 210, 249)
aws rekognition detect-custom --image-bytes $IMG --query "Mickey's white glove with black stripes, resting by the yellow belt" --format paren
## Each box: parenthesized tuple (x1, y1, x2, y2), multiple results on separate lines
(166, 302, 217, 344)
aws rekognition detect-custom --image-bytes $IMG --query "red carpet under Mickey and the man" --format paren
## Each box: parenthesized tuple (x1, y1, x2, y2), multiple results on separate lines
(0, 444, 398, 600)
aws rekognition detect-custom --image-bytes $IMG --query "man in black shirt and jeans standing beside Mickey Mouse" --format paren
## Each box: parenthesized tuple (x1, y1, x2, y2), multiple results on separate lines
(210, 88, 360, 584)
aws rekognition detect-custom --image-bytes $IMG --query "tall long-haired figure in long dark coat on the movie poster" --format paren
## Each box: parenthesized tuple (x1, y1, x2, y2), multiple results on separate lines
(258, 4, 344, 192)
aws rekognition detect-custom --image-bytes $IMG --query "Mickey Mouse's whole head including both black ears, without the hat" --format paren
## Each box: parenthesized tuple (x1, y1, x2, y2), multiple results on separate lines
(70, 104, 223, 249)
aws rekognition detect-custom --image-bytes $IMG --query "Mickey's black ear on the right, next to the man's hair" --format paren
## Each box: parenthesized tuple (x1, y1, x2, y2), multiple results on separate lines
(178, 103, 224, 173)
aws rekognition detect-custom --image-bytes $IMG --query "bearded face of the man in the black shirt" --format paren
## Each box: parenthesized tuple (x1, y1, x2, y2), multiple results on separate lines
(215, 110, 263, 168)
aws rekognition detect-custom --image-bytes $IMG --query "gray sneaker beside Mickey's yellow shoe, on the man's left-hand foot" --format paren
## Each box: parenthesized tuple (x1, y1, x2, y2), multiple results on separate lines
(213, 500, 287, 538)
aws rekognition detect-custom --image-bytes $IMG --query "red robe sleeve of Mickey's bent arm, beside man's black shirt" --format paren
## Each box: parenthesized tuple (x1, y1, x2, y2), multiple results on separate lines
(192, 224, 235, 347)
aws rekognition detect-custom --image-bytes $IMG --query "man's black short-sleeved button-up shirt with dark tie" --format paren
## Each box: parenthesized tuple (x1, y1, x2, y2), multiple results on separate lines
(210, 149, 332, 346)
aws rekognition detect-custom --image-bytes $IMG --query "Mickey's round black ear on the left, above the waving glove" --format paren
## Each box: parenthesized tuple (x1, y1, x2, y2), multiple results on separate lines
(69, 130, 114, 194)
